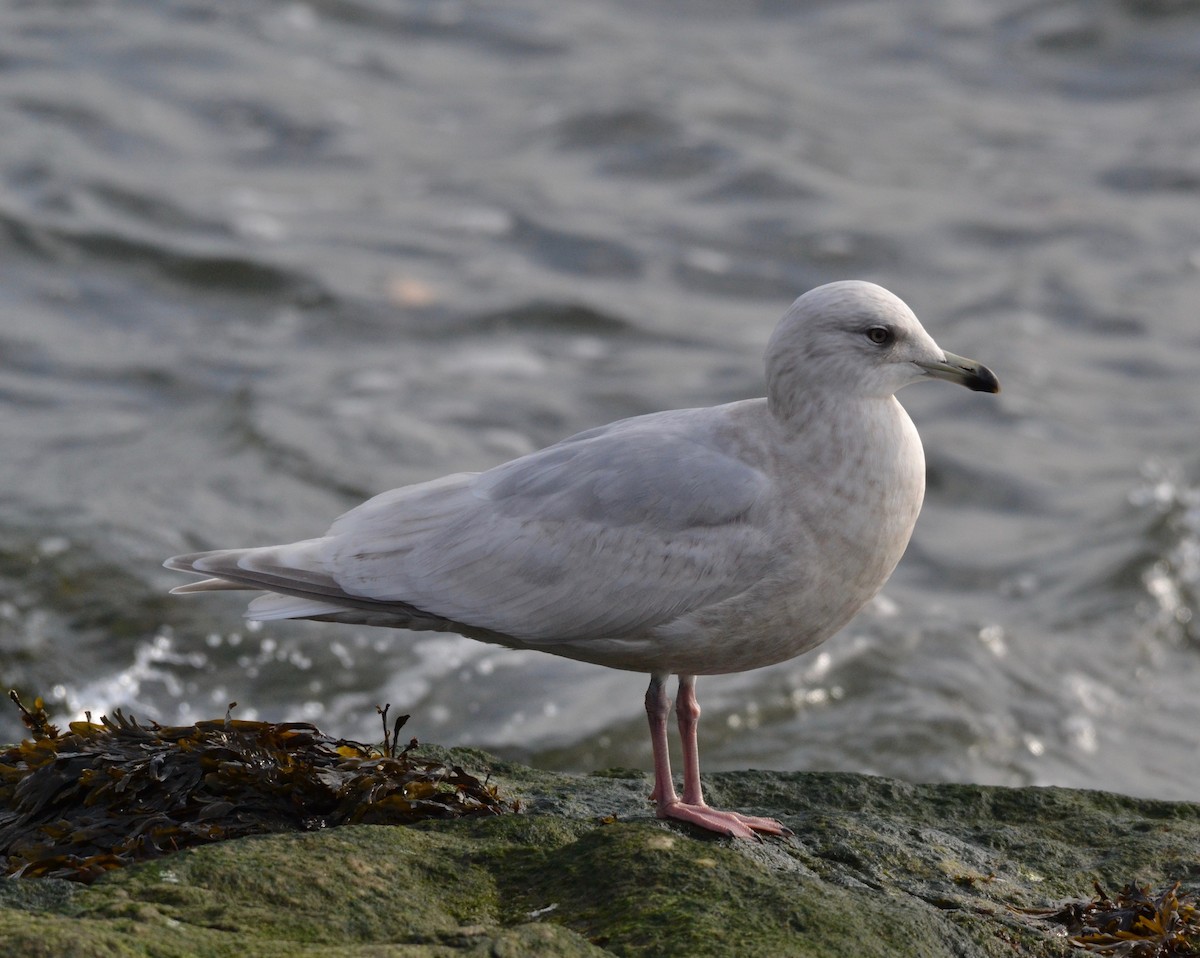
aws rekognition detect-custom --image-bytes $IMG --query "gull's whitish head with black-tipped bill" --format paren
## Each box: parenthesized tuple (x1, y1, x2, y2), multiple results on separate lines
(767, 280, 1000, 414)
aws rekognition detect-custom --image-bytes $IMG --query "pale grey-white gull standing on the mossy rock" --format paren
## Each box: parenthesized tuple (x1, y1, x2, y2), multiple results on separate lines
(166, 281, 1000, 838)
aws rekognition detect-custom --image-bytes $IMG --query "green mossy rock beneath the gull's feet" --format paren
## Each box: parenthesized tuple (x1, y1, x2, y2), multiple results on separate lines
(0, 749, 1200, 958)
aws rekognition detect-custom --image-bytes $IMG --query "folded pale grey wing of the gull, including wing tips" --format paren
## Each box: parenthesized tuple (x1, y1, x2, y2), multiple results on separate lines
(169, 419, 772, 646)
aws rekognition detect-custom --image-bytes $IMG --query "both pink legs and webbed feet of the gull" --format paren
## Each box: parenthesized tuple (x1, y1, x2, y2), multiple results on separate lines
(646, 675, 791, 838)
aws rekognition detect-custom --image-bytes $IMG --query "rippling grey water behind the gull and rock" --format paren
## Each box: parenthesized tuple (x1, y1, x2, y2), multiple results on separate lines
(0, 0, 1200, 798)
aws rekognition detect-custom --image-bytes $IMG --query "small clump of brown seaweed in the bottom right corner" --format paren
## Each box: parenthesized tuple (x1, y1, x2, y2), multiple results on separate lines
(1022, 881, 1200, 958)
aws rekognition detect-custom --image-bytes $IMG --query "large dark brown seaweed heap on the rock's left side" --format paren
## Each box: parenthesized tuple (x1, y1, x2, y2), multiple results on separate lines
(0, 693, 515, 882)
